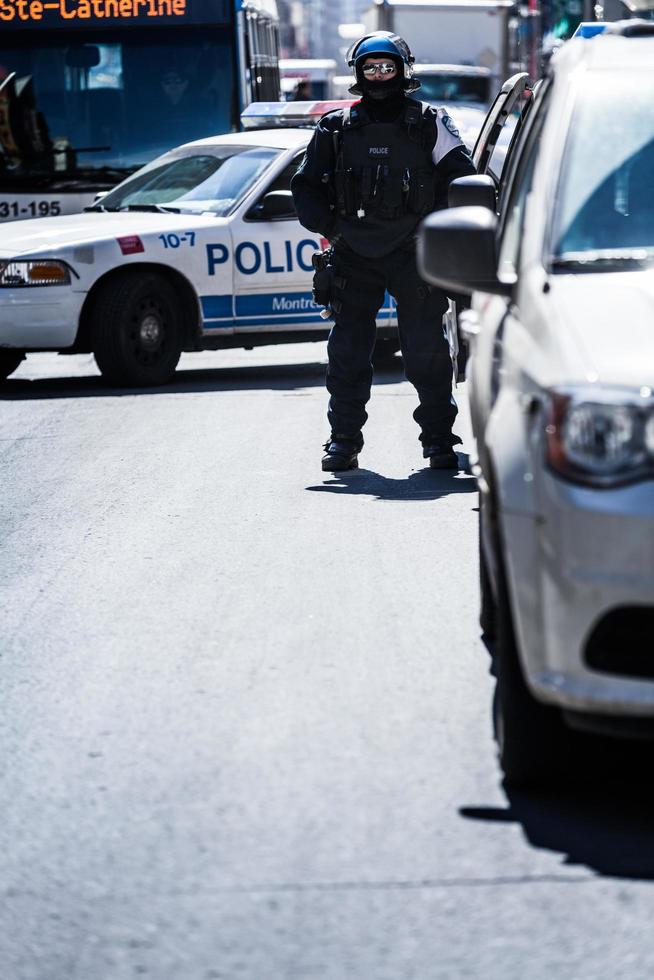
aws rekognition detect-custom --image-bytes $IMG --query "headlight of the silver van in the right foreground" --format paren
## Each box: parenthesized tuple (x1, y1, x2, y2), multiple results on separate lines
(545, 389, 654, 487)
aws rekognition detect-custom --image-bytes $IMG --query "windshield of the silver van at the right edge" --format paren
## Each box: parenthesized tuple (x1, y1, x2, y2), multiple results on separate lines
(553, 71, 654, 264)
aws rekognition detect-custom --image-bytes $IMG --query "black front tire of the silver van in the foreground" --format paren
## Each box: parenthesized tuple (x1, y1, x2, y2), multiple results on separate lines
(493, 540, 575, 789)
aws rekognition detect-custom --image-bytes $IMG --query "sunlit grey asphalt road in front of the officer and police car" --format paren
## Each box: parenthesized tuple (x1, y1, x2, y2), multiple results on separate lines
(0, 345, 654, 980)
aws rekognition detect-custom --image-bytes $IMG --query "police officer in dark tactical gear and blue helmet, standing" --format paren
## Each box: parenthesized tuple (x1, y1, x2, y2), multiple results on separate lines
(291, 31, 475, 471)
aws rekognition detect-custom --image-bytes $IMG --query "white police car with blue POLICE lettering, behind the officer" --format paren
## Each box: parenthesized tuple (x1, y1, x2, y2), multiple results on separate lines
(0, 103, 396, 385)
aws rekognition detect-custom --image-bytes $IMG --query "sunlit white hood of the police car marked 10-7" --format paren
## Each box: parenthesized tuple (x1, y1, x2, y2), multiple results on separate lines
(0, 211, 227, 259)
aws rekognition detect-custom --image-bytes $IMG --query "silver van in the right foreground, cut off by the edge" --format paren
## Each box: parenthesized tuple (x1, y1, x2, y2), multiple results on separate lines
(420, 22, 654, 784)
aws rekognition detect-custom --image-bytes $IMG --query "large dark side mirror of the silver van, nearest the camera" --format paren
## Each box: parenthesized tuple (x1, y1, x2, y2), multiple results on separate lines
(418, 207, 513, 296)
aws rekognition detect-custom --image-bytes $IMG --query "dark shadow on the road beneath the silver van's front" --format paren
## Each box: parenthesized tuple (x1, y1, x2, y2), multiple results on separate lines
(459, 756, 654, 881)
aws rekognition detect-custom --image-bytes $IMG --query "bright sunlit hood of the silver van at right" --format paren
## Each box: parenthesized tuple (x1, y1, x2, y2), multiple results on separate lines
(550, 270, 654, 387)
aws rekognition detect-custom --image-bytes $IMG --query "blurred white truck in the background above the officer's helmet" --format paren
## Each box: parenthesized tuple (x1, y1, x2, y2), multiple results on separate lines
(363, 0, 520, 91)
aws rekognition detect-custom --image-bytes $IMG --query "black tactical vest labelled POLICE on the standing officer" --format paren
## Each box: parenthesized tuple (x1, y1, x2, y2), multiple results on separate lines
(333, 100, 435, 258)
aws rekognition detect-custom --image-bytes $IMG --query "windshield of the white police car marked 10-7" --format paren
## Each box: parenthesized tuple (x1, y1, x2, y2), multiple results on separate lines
(99, 146, 281, 215)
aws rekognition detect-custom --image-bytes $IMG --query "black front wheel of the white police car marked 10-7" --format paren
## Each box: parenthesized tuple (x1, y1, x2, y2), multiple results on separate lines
(91, 270, 183, 386)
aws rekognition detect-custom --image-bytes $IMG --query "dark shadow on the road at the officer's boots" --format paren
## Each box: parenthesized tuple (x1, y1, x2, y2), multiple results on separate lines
(307, 453, 477, 500)
